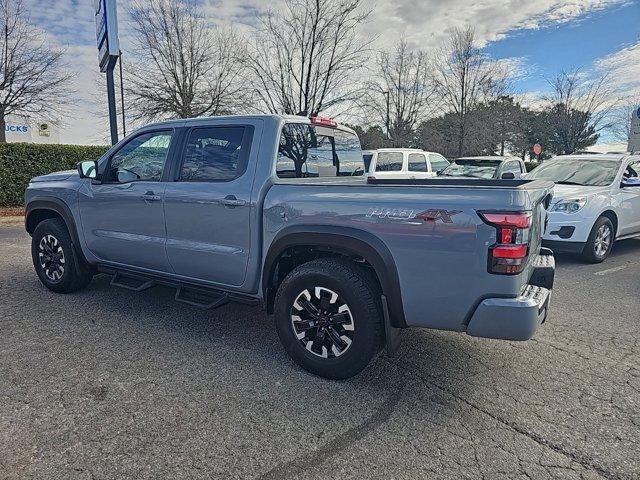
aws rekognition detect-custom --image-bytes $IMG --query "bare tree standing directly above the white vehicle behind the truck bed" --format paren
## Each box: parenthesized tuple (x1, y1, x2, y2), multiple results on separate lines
(362, 40, 436, 147)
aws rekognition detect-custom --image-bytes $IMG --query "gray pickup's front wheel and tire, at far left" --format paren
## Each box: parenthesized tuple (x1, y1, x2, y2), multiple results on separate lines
(31, 218, 93, 293)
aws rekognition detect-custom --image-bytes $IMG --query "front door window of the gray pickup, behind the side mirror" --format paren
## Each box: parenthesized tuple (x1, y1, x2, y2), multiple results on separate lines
(105, 131, 171, 183)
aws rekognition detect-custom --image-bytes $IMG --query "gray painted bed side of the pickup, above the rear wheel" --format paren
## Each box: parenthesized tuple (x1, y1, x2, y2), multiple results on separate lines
(263, 179, 553, 331)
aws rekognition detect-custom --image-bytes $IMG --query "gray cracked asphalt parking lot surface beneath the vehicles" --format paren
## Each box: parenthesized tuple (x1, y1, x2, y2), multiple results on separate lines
(0, 226, 640, 479)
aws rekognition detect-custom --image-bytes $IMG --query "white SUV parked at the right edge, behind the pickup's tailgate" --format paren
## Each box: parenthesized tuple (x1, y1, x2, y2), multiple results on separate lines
(527, 154, 640, 263)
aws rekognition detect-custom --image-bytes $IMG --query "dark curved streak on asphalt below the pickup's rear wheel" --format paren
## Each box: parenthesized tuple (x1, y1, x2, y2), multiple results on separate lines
(258, 385, 404, 480)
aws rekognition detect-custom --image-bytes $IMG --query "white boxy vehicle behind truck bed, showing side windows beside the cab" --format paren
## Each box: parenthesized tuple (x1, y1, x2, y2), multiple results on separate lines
(369, 148, 449, 179)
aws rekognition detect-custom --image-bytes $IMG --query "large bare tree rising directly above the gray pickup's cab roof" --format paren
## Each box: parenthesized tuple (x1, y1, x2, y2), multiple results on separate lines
(246, 0, 370, 115)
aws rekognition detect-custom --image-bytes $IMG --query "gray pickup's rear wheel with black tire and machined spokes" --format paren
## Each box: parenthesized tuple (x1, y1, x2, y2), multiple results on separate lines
(274, 259, 383, 379)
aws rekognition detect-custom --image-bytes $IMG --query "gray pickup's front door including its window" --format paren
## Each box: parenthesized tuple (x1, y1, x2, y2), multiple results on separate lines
(79, 130, 173, 272)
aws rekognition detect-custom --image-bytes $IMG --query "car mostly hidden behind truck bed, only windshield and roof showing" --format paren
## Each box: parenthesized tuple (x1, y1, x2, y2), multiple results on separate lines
(439, 156, 527, 179)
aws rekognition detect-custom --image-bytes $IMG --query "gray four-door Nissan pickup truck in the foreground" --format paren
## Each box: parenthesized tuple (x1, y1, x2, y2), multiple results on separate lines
(25, 115, 555, 378)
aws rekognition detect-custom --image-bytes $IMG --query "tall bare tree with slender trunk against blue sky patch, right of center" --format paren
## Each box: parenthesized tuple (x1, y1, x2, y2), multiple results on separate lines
(435, 27, 508, 155)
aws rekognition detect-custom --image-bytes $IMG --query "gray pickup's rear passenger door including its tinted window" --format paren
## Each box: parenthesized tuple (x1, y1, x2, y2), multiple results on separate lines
(165, 120, 262, 286)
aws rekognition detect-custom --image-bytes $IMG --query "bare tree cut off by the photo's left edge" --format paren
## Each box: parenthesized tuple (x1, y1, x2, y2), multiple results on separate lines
(0, 0, 71, 143)
